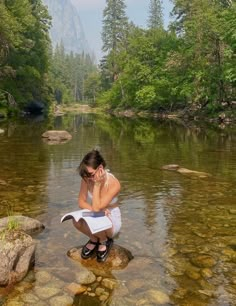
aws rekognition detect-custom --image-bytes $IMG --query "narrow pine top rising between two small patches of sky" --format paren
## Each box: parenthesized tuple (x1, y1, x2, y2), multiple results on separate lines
(148, 0, 163, 29)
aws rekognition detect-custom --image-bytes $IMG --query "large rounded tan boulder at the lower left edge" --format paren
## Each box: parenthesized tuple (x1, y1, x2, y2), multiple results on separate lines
(0, 231, 36, 286)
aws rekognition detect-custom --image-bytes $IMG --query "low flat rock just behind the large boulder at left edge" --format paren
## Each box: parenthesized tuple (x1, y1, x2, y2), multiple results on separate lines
(0, 215, 45, 234)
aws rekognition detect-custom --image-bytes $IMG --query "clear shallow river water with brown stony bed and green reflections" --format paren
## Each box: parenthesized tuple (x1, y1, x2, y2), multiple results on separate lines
(0, 114, 236, 306)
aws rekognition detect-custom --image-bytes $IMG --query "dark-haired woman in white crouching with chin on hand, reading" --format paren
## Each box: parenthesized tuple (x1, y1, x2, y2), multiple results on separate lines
(73, 150, 121, 261)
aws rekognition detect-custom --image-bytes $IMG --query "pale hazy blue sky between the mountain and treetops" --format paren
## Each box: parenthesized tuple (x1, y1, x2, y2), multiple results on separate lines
(71, 0, 172, 61)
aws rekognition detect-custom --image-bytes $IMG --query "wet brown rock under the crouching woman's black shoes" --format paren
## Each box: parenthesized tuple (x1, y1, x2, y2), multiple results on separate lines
(67, 244, 133, 275)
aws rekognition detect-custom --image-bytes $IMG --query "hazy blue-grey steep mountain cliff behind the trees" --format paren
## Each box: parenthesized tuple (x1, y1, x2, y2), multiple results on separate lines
(42, 0, 91, 54)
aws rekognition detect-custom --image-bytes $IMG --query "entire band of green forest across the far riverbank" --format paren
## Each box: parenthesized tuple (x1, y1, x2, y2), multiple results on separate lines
(0, 0, 236, 119)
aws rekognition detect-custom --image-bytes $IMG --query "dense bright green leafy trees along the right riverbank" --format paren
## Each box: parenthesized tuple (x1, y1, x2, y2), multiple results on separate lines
(97, 0, 236, 116)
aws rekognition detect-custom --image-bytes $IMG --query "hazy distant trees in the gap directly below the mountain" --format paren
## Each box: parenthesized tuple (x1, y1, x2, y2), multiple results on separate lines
(50, 44, 99, 104)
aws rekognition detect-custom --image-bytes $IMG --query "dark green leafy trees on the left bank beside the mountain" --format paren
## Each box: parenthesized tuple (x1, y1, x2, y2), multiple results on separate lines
(0, 0, 50, 108)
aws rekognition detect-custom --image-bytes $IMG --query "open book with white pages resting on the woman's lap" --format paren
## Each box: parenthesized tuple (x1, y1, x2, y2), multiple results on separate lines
(61, 209, 112, 234)
